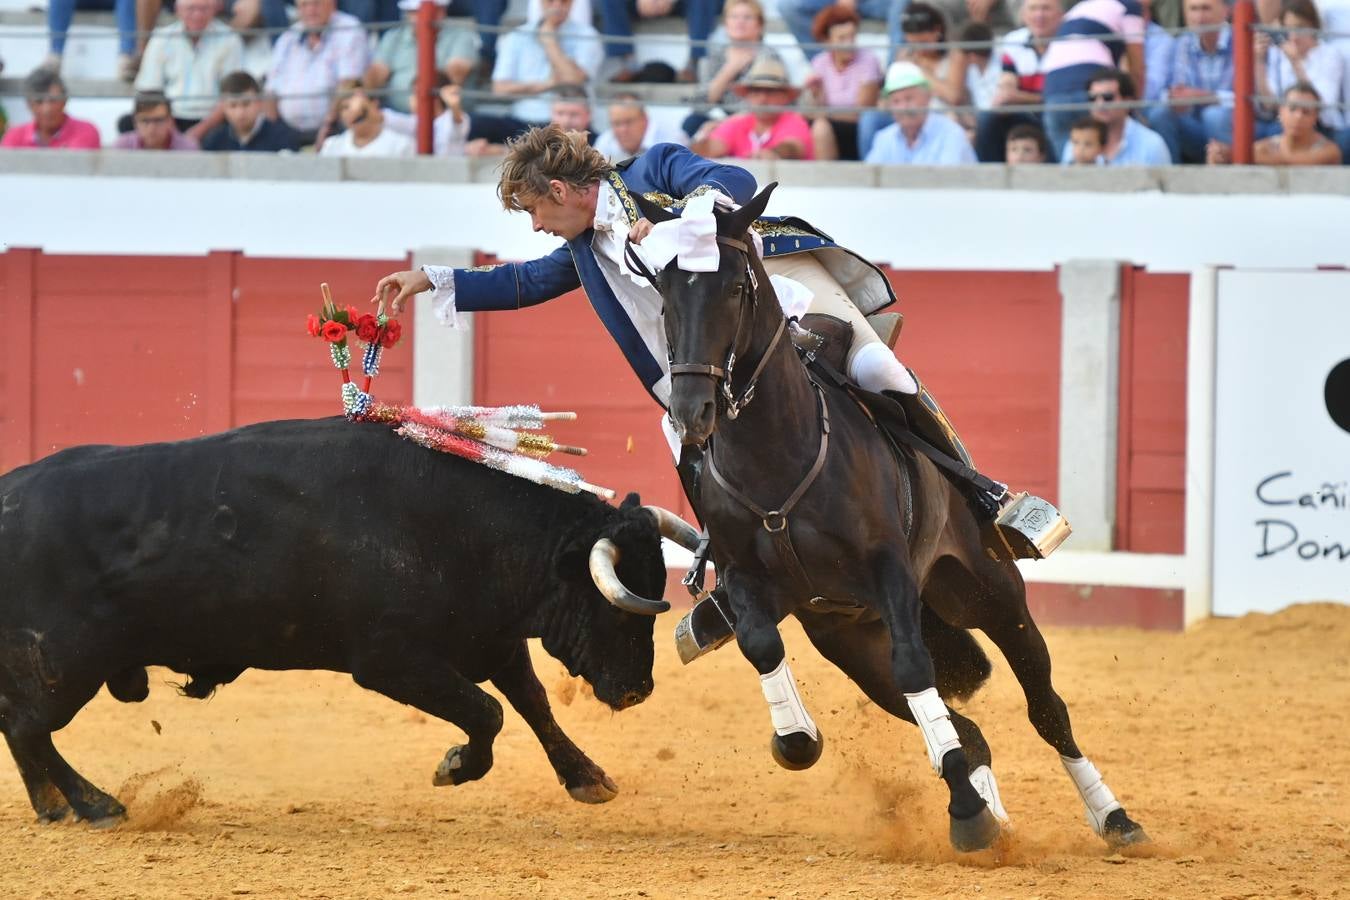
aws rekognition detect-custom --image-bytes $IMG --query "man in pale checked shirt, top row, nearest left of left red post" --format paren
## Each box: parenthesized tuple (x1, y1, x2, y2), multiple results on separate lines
(267, 0, 370, 144)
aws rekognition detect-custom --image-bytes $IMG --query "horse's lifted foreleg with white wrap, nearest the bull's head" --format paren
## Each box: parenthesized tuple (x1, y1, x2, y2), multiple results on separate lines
(728, 575, 825, 770)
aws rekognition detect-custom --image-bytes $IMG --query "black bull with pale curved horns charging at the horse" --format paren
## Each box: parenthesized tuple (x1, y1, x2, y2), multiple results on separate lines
(0, 418, 666, 822)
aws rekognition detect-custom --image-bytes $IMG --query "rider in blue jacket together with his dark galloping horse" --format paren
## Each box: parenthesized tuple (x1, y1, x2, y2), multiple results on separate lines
(375, 125, 1148, 850)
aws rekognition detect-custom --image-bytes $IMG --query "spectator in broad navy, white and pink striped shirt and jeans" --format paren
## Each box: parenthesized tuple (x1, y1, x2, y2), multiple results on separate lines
(1041, 0, 1146, 150)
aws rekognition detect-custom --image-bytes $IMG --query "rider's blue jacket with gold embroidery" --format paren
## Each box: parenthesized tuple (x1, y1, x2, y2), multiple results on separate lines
(455, 143, 895, 404)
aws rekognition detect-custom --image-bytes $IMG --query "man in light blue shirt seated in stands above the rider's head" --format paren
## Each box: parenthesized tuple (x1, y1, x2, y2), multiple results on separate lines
(493, 0, 603, 124)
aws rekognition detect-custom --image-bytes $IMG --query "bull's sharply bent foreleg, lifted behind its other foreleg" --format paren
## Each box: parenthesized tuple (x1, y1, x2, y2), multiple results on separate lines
(351, 648, 502, 787)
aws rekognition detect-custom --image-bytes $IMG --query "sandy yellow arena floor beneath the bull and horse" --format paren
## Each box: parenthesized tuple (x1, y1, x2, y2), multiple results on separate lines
(0, 606, 1350, 900)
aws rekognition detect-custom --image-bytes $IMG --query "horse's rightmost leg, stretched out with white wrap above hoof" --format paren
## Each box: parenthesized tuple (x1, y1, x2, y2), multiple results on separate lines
(976, 561, 1149, 846)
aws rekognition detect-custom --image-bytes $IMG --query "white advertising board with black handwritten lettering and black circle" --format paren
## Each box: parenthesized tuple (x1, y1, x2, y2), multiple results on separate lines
(1214, 270, 1350, 615)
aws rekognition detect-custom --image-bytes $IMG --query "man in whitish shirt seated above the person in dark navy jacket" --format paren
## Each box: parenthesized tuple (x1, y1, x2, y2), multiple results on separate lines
(136, 0, 244, 142)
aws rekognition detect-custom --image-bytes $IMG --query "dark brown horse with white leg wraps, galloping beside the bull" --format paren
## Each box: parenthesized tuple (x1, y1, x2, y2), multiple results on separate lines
(643, 185, 1148, 850)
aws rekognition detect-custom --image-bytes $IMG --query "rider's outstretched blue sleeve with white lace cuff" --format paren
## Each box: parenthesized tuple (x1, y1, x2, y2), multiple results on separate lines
(423, 244, 581, 324)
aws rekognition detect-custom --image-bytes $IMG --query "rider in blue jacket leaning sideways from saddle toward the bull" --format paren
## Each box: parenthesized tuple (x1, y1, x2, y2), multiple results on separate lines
(375, 125, 1048, 636)
